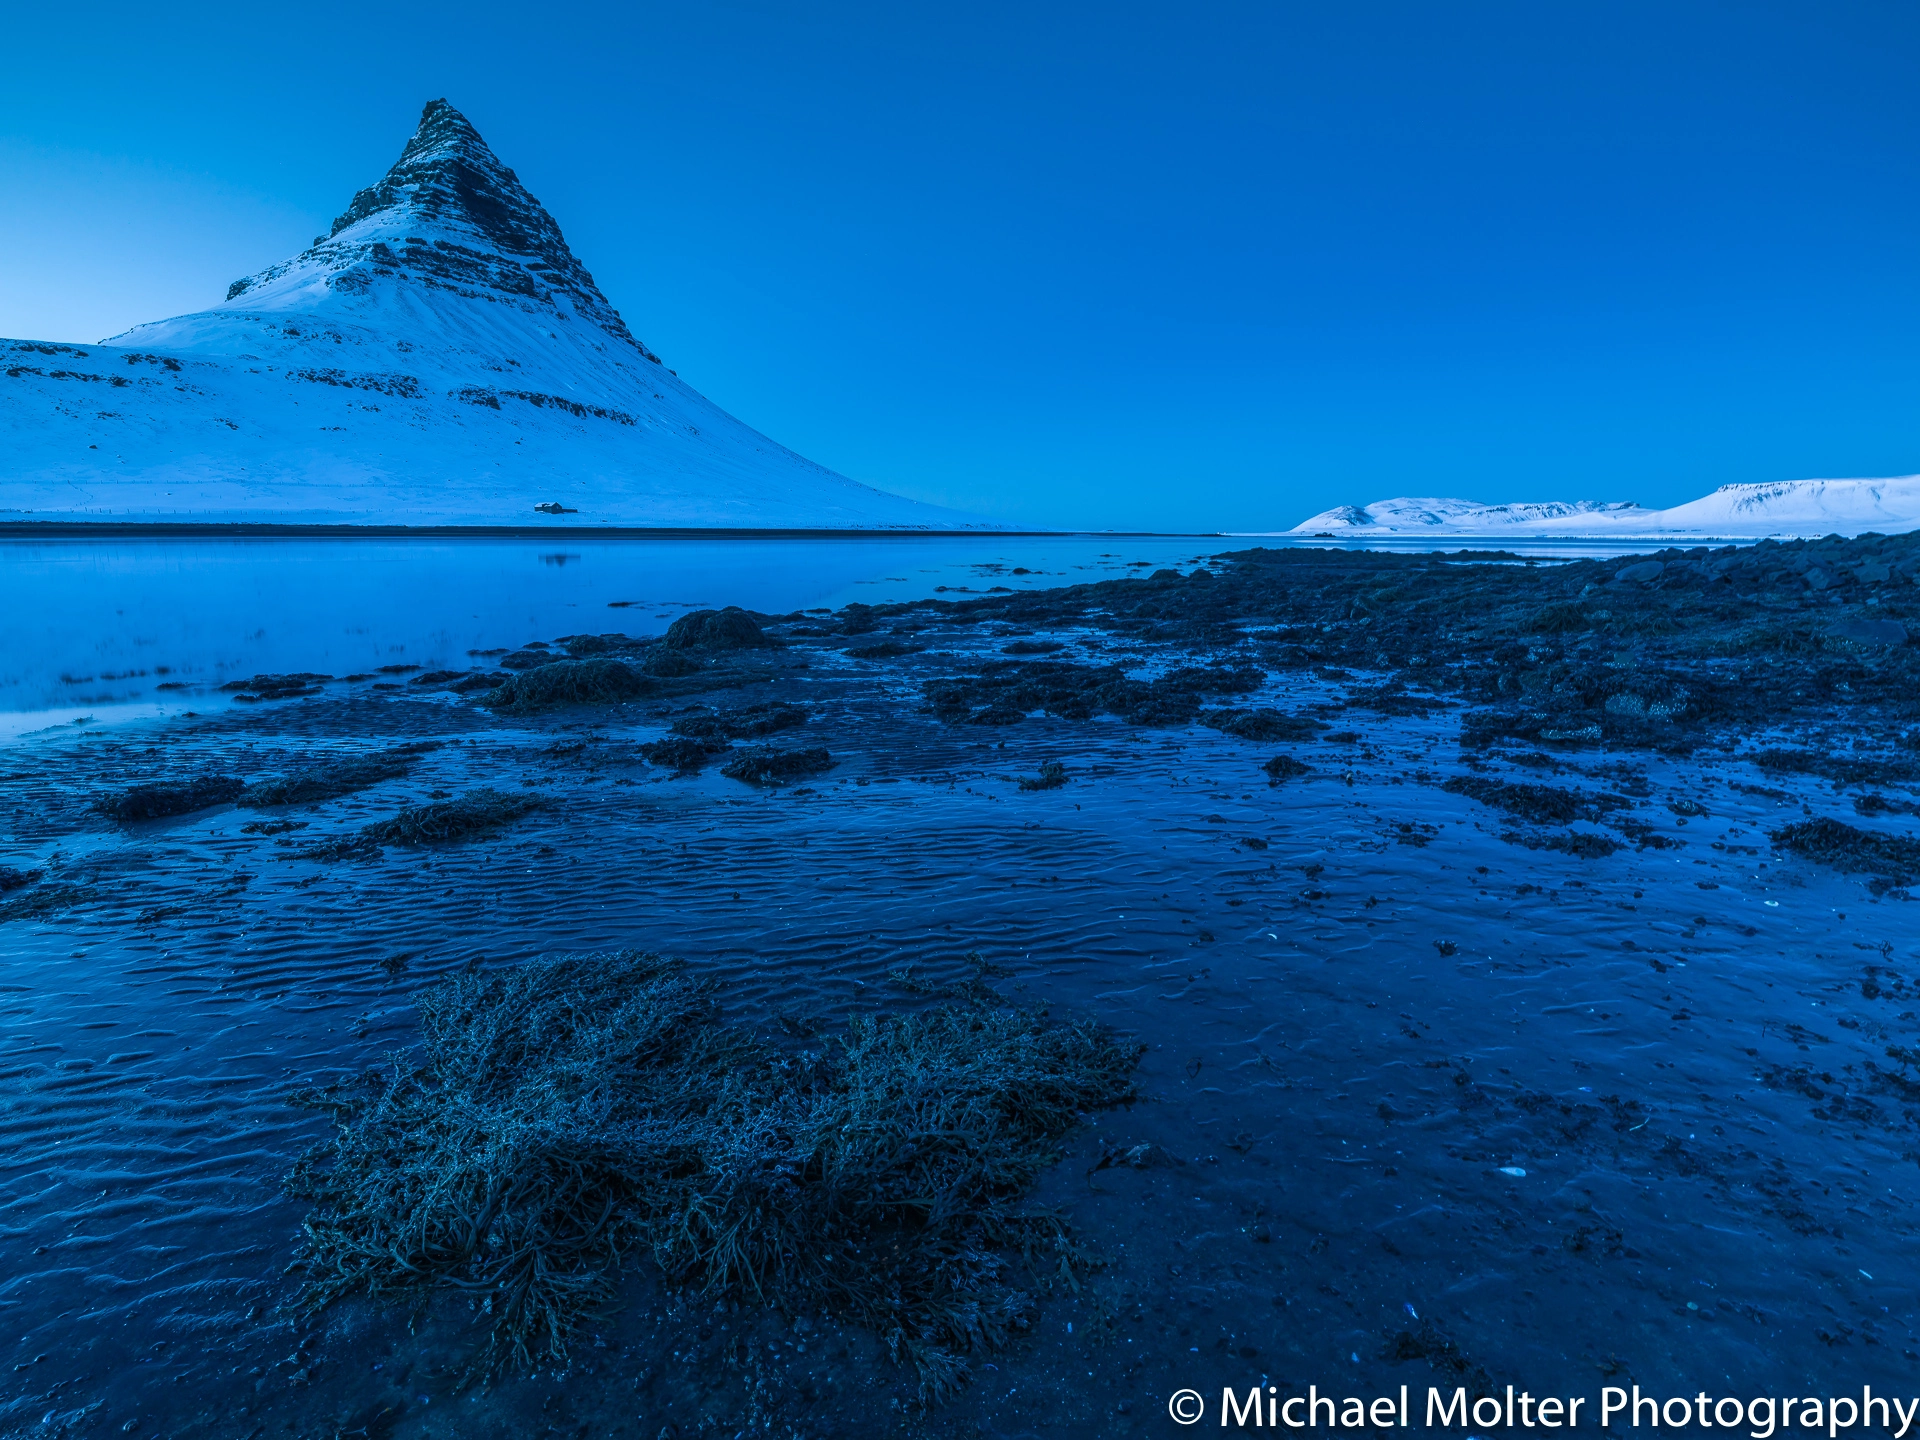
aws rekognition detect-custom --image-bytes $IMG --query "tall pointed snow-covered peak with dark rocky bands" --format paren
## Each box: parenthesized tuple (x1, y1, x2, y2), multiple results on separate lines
(0, 100, 996, 530)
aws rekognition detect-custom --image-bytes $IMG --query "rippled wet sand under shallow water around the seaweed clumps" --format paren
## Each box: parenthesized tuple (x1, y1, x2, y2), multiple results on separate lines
(0, 579, 1920, 1440)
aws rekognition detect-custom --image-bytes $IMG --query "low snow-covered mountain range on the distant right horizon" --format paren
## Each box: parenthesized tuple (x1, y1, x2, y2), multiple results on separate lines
(1286, 474, 1920, 541)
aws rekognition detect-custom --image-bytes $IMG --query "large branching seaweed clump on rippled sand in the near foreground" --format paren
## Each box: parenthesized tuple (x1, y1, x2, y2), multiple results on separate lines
(288, 952, 1140, 1396)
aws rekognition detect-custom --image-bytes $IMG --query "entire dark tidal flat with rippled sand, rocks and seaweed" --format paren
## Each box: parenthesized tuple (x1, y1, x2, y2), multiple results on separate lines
(0, 536, 1920, 1440)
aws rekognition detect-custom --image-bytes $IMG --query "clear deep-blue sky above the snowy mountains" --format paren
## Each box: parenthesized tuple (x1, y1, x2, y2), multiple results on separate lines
(0, 0, 1920, 528)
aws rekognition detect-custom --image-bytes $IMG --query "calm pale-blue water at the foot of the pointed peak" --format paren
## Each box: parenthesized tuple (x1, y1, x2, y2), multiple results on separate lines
(0, 536, 1681, 737)
